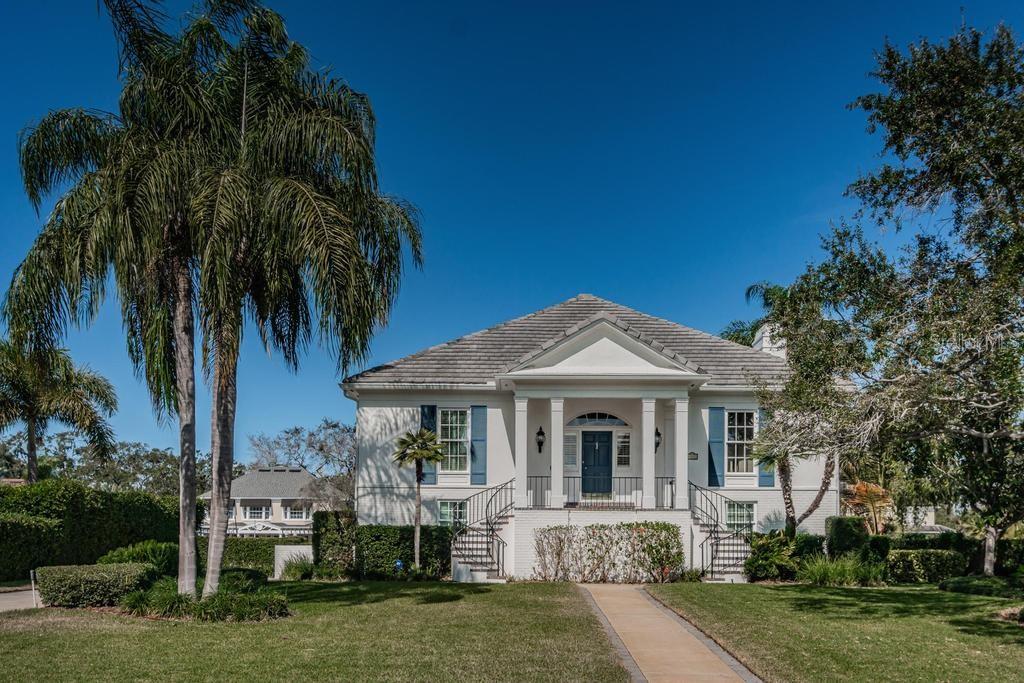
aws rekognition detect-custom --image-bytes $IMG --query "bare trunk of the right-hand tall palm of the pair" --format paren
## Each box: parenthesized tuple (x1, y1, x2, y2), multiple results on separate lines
(203, 351, 238, 597)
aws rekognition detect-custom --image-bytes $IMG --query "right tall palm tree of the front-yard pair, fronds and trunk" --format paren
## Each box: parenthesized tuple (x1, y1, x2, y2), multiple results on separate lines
(191, 8, 421, 595)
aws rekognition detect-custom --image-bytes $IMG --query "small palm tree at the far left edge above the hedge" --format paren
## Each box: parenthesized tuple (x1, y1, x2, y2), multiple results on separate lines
(0, 340, 118, 481)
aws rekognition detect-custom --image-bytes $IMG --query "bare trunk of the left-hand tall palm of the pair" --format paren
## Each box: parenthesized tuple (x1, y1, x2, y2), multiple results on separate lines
(173, 265, 198, 595)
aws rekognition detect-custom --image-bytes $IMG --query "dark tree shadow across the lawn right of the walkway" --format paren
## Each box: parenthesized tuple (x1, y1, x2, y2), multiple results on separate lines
(769, 586, 1024, 644)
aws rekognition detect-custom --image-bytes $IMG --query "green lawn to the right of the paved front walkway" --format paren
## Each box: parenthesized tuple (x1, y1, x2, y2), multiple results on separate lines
(650, 584, 1024, 682)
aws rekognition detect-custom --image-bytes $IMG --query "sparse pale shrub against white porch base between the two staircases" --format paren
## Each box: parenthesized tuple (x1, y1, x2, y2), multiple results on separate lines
(534, 522, 684, 584)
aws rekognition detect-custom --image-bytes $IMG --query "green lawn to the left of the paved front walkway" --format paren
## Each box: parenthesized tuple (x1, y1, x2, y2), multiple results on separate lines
(0, 583, 627, 682)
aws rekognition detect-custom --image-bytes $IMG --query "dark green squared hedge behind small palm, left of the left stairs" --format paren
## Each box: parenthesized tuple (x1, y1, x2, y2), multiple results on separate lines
(312, 512, 452, 579)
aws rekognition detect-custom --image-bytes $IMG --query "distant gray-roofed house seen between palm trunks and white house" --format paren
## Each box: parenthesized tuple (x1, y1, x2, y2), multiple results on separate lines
(200, 465, 321, 536)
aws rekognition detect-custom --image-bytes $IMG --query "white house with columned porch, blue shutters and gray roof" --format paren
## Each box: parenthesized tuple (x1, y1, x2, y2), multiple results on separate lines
(342, 294, 839, 580)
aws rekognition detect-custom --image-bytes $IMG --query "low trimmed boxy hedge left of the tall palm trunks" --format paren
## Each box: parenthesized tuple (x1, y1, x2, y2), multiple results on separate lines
(36, 562, 157, 607)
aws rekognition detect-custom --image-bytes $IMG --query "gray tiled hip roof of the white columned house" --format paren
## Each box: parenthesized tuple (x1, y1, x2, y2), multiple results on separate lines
(344, 294, 786, 386)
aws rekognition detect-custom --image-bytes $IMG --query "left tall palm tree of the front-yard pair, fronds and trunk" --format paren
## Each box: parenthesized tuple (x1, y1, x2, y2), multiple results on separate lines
(4, 0, 256, 594)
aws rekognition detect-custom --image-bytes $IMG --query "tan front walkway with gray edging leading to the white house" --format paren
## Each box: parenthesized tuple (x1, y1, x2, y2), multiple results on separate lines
(583, 584, 758, 683)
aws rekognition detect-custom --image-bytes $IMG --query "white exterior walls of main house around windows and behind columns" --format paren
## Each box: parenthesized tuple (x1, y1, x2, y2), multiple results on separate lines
(356, 391, 839, 544)
